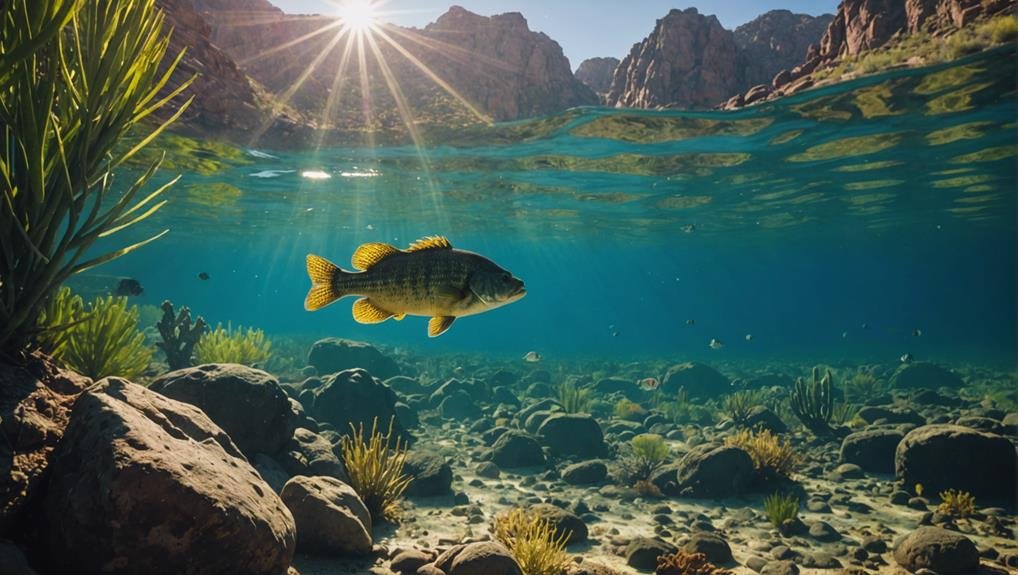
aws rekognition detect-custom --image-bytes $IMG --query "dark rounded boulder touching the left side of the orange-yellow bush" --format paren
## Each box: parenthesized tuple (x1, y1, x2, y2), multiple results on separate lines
(676, 445, 755, 499)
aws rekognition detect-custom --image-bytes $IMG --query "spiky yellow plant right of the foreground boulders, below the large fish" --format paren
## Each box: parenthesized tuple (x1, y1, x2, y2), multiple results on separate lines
(340, 417, 411, 522)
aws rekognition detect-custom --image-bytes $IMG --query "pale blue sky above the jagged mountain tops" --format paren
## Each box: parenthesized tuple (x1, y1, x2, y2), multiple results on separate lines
(270, 0, 838, 69)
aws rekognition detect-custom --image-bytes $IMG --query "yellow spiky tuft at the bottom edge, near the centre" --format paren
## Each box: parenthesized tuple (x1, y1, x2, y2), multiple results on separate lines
(492, 507, 572, 575)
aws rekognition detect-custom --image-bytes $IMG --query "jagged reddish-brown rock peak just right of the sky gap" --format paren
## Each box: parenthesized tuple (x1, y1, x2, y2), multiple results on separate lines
(607, 8, 742, 108)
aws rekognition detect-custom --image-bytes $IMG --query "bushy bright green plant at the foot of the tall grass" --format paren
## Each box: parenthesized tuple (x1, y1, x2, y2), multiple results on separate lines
(40, 288, 153, 380)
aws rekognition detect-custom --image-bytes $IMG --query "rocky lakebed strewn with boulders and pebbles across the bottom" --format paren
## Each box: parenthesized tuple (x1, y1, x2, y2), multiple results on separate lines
(0, 339, 1018, 575)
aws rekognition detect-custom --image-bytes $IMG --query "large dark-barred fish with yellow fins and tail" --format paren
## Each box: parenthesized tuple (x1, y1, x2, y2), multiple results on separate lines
(304, 236, 526, 338)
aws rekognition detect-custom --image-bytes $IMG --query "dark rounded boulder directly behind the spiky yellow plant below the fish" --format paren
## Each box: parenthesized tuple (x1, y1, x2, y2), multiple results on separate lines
(301, 368, 410, 441)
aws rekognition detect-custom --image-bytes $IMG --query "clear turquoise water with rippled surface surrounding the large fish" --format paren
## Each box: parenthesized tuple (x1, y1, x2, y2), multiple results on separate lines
(77, 47, 1018, 366)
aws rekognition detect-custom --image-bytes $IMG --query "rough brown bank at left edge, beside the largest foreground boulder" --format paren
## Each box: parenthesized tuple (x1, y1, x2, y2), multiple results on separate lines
(0, 353, 92, 533)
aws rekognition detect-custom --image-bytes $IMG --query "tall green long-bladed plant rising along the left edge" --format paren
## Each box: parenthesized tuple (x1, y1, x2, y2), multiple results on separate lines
(0, 0, 190, 353)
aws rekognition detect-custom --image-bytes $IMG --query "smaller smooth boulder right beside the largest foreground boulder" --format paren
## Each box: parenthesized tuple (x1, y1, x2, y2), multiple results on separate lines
(279, 475, 372, 556)
